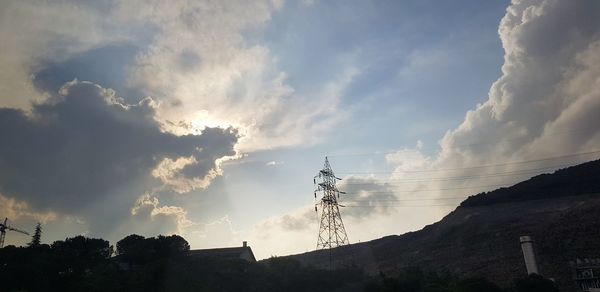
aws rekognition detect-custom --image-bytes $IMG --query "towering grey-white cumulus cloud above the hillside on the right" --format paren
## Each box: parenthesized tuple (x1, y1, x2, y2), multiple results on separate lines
(246, 0, 600, 256)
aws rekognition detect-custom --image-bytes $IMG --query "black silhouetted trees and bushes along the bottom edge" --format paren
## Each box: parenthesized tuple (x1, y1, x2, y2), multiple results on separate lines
(0, 232, 555, 292)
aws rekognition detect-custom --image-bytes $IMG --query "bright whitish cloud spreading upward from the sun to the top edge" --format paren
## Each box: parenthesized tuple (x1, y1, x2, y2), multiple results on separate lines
(115, 1, 357, 151)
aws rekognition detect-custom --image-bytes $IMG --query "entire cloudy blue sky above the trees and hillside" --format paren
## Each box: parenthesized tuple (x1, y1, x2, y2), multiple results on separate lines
(0, 0, 600, 258)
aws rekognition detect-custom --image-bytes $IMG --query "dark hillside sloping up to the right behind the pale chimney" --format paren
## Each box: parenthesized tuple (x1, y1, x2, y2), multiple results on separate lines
(290, 160, 600, 291)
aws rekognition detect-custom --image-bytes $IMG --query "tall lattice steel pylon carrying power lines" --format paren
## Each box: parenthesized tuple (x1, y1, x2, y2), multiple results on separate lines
(313, 157, 349, 249)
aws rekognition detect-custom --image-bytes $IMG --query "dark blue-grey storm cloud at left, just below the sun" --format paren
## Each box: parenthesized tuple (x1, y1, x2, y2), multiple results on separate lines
(0, 81, 237, 214)
